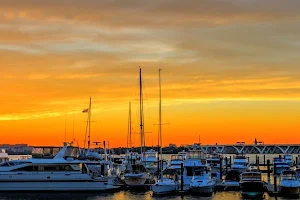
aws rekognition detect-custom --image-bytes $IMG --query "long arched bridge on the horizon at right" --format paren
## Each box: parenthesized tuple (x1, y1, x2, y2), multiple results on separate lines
(187, 144, 300, 154)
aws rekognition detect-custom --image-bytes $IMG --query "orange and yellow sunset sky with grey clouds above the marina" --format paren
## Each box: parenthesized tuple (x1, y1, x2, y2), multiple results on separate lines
(0, 0, 300, 147)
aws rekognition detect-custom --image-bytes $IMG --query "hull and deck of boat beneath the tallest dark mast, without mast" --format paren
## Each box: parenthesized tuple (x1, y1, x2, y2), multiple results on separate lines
(124, 164, 150, 188)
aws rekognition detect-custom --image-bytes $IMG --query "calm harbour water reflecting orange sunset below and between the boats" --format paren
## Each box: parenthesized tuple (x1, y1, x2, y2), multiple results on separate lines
(4, 154, 296, 200)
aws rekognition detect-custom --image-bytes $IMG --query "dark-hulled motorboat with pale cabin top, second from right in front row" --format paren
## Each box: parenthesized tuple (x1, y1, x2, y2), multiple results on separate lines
(240, 170, 264, 198)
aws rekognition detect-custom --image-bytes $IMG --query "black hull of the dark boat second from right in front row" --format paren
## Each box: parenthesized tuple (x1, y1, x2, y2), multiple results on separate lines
(240, 181, 264, 198)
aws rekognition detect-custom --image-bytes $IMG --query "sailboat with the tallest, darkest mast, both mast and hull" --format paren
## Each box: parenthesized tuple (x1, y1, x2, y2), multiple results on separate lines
(124, 68, 150, 188)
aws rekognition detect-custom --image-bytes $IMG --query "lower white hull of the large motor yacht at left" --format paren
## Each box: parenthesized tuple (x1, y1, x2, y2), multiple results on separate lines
(0, 181, 118, 191)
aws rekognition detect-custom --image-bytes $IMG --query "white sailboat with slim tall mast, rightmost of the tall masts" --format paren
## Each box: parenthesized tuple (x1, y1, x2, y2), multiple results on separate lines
(151, 69, 179, 195)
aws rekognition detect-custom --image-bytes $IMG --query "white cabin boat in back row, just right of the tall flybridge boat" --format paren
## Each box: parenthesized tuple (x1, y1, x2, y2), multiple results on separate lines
(206, 153, 226, 179)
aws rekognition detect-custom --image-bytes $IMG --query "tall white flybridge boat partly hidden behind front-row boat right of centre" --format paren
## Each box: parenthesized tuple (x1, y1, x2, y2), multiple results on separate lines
(181, 150, 206, 191)
